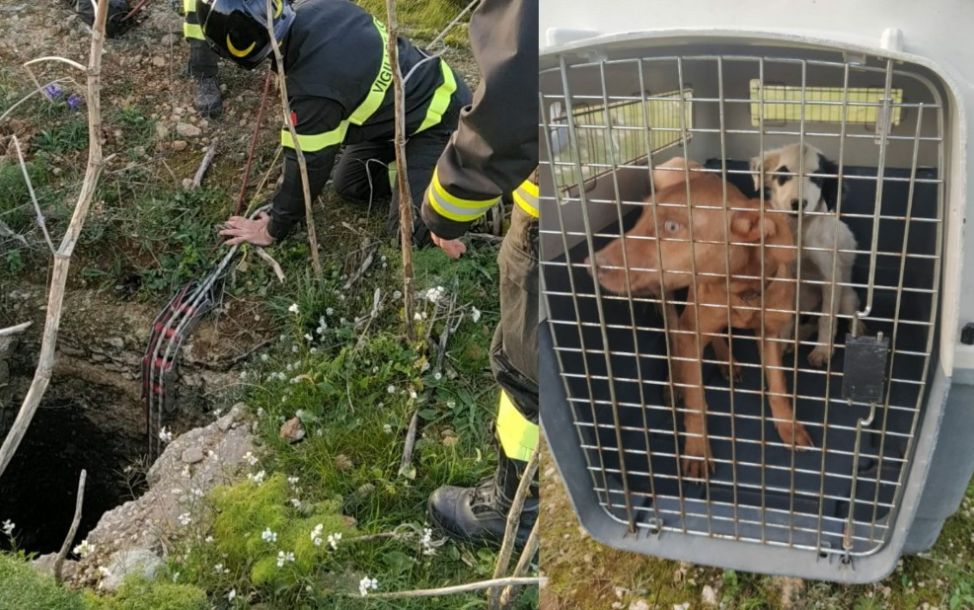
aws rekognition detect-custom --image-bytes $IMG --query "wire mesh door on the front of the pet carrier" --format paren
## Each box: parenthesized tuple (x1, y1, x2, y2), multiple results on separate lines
(539, 54, 944, 559)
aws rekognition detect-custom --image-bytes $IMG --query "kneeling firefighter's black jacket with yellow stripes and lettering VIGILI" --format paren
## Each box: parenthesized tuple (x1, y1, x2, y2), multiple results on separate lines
(268, 0, 457, 239)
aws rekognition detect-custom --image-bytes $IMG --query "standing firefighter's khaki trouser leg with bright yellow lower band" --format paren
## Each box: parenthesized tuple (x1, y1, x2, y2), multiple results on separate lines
(490, 205, 538, 500)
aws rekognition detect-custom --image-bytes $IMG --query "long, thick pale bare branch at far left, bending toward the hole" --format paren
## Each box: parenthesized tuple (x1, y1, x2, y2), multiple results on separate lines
(0, 0, 108, 477)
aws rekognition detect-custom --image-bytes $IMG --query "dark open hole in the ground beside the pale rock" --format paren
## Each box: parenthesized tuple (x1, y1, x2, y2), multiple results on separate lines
(0, 397, 144, 554)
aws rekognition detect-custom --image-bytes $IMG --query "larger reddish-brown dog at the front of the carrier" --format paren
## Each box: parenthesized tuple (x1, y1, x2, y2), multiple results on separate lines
(586, 160, 812, 477)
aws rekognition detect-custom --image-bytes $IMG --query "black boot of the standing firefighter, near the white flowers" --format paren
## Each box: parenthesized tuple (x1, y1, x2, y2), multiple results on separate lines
(428, 457, 538, 545)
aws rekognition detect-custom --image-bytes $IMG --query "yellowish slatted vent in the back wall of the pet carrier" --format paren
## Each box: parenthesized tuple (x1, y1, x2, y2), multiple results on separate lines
(751, 79, 903, 127)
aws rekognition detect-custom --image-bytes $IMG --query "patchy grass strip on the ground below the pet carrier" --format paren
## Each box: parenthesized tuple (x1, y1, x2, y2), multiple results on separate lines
(541, 456, 974, 610)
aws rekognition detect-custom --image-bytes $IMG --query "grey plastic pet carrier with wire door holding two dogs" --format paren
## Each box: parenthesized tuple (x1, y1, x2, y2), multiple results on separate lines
(539, 0, 974, 583)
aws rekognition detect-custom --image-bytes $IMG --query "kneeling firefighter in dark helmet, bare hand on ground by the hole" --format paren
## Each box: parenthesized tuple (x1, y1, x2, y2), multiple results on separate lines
(196, 0, 470, 246)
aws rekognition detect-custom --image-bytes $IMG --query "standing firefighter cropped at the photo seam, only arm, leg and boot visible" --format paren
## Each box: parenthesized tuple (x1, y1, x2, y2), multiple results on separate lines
(422, 0, 539, 543)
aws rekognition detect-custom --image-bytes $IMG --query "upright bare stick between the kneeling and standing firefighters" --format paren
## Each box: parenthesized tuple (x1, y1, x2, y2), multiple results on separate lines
(386, 0, 416, 341)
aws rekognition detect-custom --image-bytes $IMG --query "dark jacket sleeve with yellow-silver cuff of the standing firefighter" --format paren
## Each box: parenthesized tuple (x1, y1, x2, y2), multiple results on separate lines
(422, 0, 538, 239)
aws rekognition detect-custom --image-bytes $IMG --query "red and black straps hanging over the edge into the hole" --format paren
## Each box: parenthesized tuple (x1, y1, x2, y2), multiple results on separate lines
(142, 206, 270, 459)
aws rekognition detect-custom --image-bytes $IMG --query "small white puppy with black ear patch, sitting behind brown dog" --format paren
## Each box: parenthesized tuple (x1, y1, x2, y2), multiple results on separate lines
(751, 144, 859, 366)
